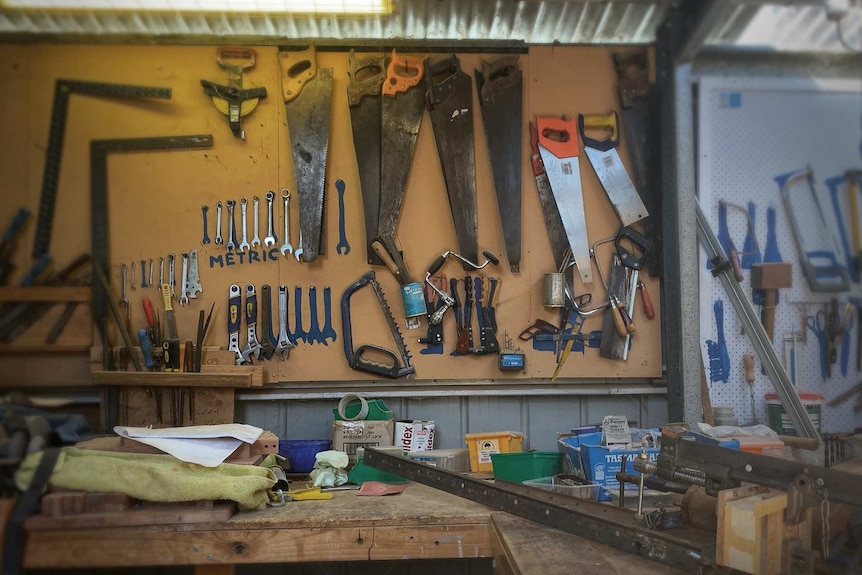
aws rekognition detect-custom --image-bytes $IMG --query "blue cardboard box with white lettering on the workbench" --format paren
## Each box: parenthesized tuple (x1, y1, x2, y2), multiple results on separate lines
(557, 433, 661, 501)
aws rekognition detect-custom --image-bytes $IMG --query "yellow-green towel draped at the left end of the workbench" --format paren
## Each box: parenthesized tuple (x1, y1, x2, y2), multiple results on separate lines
(15, 447, 276, 510)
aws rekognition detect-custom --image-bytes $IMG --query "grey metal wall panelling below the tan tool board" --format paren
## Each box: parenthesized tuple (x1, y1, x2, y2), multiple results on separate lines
(236, 395, 667, 451)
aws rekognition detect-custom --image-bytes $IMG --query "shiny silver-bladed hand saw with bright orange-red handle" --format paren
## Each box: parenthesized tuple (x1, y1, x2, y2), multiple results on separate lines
(536, 116, 593, 284)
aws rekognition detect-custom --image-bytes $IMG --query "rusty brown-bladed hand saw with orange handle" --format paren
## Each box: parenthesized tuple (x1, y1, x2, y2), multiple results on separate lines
(382, 50, 425, 250)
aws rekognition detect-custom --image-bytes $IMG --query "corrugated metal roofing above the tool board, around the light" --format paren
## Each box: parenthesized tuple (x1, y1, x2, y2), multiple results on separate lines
(0, 0, 676, 44)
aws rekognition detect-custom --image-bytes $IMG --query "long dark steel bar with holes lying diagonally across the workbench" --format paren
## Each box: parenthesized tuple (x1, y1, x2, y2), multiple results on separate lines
(363, 448, 715, 573)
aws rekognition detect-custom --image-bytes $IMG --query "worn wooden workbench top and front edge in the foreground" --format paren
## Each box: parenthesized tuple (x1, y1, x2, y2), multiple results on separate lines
(24, 483, 688, 575)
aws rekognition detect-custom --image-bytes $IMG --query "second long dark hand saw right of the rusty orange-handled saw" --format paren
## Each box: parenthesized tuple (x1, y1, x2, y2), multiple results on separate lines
(476, 56, 523, 272)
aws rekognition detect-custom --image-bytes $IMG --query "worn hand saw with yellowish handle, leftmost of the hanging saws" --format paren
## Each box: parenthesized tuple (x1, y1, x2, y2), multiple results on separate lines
(278, 46, 332, 262)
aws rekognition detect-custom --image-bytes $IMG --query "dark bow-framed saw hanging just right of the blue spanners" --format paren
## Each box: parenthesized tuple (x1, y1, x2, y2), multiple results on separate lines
(341, 271, 416, 379)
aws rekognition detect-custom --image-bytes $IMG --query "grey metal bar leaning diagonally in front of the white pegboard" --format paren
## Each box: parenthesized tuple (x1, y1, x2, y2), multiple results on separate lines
(695, 200, 820, 439)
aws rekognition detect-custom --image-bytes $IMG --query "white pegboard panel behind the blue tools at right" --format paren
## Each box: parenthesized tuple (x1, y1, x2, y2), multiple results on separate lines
(697, 76, 862, 432)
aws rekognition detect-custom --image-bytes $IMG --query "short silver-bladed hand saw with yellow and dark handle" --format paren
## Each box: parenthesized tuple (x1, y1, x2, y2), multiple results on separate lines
(578, 112, 649, 227)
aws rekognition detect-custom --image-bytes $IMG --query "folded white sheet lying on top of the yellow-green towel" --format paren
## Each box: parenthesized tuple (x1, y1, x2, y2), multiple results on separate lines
(114, 423, 263, 467)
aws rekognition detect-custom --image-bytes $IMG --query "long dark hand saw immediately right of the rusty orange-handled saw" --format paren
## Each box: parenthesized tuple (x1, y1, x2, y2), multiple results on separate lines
(425, 54, 478, 270)
